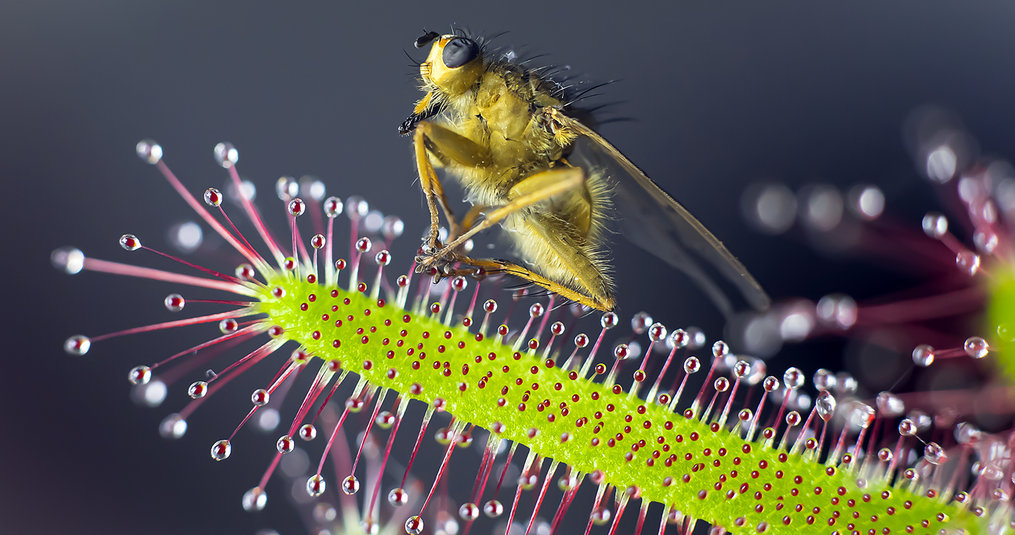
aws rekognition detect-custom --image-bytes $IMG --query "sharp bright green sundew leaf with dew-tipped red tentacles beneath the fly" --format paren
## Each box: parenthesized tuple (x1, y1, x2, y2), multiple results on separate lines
(53, 140, 1011, 534)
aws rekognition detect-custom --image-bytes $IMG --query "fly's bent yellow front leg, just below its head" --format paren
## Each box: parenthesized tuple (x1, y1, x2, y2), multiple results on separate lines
(412, 121, 489, 272)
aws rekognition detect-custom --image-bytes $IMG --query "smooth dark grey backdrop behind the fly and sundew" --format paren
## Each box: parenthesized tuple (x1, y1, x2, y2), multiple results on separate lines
(0, 1, 1015, 535)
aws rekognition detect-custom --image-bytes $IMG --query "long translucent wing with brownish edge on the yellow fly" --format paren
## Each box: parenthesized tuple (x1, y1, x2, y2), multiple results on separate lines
(552, 112, 770, 315)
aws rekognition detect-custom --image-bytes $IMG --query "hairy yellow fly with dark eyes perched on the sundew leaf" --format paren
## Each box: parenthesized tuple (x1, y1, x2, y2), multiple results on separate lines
(399, 31, 768, 312)
